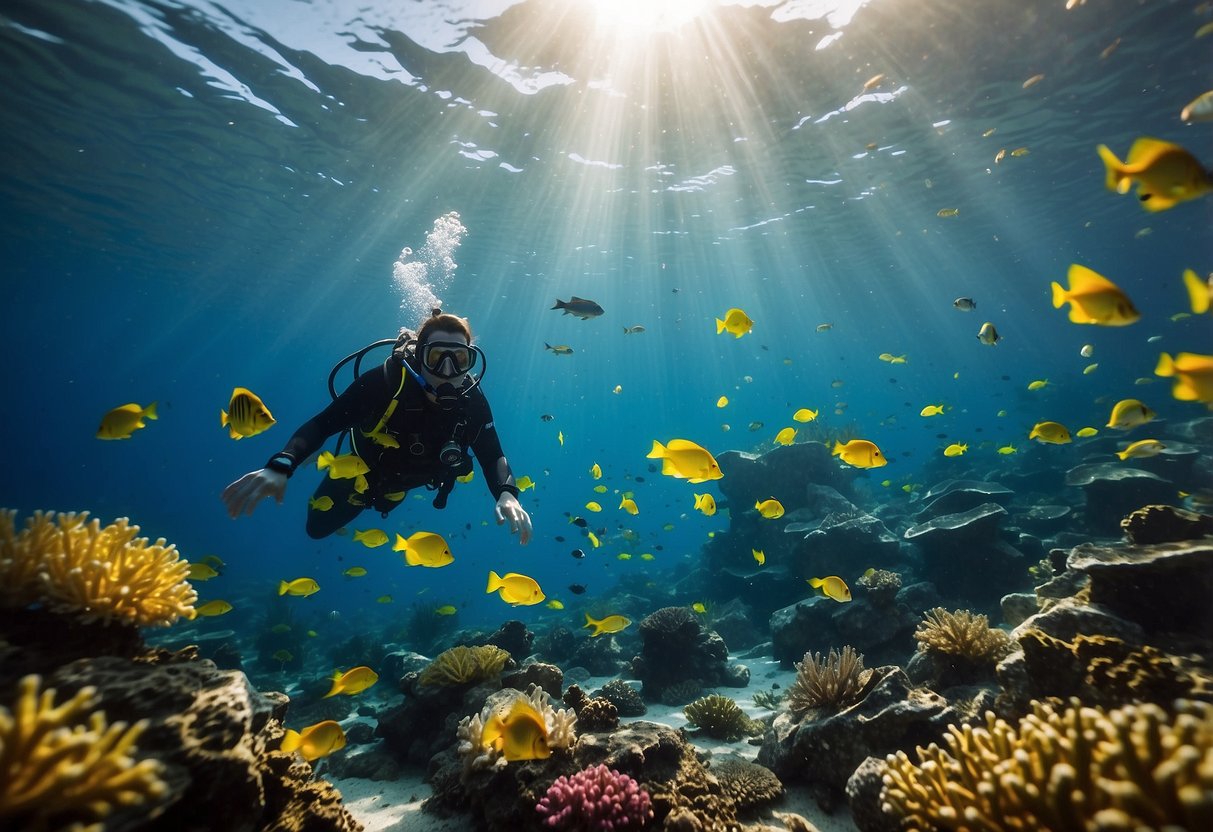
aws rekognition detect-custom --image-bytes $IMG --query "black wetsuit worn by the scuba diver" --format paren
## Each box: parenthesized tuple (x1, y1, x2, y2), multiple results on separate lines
(270, 360, 518, 537)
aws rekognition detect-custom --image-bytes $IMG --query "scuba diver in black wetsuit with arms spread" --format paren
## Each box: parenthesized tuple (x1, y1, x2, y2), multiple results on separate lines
(222, 309, 531, 546)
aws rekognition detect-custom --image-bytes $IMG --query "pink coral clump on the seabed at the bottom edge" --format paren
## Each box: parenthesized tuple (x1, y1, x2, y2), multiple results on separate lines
(535, 765, 653, 832)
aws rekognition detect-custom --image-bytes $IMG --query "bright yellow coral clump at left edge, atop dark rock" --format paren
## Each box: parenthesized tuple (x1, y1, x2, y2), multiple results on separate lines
(0, 511, 198, 627)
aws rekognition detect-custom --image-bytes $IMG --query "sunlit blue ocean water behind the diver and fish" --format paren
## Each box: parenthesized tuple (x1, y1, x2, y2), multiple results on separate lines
(0, 0, 1213, 645)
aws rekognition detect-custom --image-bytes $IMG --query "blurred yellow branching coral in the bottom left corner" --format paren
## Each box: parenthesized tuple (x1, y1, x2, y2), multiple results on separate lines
(0, 676, 166, 830)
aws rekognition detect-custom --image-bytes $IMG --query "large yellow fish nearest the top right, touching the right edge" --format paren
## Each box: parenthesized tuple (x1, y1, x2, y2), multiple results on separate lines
(1095, 136, 1213, 211)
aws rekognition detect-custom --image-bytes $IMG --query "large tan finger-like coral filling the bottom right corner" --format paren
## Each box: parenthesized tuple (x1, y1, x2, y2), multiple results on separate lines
(881, 700, 1213, 832)
